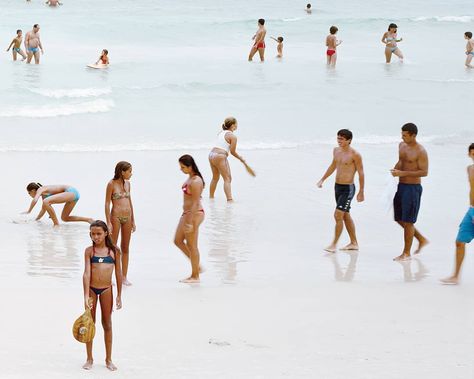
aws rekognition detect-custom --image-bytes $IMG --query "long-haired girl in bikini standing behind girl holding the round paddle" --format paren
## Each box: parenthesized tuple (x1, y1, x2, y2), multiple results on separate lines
(105, 161, 136, 286)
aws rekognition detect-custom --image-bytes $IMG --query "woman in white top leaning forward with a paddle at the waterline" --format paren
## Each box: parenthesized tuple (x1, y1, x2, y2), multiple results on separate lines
(209, 117, 255, 201)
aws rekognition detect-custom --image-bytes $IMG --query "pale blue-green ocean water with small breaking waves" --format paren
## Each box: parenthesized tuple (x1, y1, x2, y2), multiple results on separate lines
(0, 0, 474, 152)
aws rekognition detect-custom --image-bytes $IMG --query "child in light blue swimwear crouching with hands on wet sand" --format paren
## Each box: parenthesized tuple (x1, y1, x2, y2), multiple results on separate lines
(24, 183, 94, 226)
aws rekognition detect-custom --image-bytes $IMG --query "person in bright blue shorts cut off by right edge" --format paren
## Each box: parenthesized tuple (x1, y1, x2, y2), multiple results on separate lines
(441, 143, 474, 284)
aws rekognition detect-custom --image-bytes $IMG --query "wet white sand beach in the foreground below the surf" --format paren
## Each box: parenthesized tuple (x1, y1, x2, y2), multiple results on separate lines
(0, 145, 474, 379)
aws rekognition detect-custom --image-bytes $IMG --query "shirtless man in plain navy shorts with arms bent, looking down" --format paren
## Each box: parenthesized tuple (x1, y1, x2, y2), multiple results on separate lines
(390, 123, 428, 261)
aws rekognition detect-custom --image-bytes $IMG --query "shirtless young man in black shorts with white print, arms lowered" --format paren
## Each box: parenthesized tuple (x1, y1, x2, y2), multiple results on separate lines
(317, 129, 365, 253)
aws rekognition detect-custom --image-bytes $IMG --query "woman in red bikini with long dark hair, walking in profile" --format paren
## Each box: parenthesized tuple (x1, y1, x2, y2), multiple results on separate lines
(174, 155, 204, 283)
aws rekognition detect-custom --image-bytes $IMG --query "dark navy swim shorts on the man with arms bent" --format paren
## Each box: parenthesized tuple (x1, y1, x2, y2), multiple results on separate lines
(393, 183, 423, 224)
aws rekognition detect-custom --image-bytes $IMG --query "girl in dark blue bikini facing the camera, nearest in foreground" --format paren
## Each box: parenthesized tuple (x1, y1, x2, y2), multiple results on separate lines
(82, 221, 122, 371)
